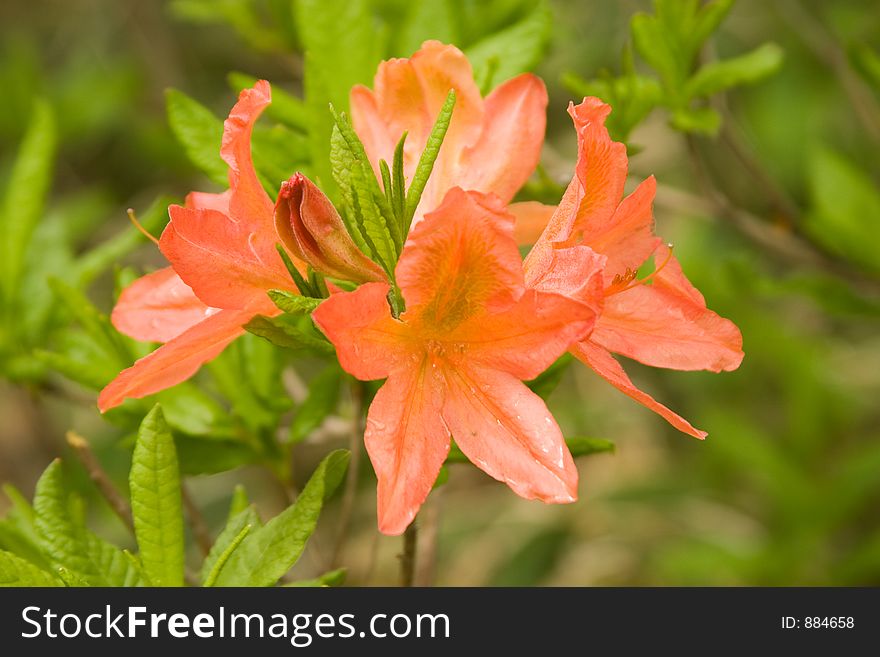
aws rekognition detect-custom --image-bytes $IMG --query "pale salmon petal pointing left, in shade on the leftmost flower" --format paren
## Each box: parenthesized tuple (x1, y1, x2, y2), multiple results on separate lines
(110, 267, 217, 342)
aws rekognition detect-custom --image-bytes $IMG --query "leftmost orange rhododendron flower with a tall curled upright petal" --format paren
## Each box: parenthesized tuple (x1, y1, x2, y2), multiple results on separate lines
(98, 81, 296, 411)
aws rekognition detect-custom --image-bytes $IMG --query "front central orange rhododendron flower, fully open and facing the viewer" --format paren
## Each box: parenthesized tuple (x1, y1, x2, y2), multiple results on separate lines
(313, 188, 604, 534)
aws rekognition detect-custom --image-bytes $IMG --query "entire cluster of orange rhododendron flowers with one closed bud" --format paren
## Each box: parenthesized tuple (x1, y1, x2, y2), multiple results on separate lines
(98, 42, 743, 534)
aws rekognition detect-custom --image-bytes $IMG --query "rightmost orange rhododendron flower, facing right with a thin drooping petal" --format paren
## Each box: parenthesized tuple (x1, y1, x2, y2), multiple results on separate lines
(525, 98, 743, 438)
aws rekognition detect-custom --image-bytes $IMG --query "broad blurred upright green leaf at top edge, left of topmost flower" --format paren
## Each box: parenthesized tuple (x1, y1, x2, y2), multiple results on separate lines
(295, 0, 381, 198)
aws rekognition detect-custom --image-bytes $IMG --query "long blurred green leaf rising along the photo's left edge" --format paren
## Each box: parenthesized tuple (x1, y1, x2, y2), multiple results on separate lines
(0, 100, 57, 303)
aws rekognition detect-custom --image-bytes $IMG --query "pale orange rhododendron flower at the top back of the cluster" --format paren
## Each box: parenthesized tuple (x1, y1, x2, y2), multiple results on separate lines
(351, 41, 547, 231)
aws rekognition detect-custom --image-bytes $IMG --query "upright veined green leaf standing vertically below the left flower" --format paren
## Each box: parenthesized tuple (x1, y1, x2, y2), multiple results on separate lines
(129, 404, 184, 586)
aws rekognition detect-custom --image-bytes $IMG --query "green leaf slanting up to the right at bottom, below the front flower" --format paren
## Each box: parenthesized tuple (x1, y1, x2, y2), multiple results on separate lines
(216, 450, 350, 586)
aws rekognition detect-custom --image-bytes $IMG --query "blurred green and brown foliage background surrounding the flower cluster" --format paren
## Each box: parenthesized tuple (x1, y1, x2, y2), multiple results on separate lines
(0, 0, 880, 586)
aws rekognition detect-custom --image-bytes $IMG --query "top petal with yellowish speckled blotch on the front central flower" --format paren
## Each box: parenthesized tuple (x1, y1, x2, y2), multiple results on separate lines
(396, 187, 523, 334)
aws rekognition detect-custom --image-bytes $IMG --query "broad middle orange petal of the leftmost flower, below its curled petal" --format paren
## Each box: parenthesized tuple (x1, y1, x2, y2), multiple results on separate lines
(159, 205, 293, 308)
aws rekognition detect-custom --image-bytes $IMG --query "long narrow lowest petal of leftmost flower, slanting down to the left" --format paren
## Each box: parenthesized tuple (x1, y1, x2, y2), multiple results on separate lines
(98, 307, 264, 413)
